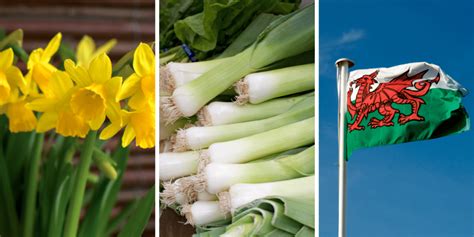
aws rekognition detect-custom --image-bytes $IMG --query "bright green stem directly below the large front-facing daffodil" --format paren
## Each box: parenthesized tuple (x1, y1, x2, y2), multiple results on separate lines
(64, 131, 97, 237)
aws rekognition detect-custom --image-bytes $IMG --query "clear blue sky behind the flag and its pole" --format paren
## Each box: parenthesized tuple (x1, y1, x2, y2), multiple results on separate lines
(319, 0, 474, 237)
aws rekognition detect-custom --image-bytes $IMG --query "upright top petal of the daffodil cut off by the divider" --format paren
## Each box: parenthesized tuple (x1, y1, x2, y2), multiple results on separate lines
(133, 43, 155, 76)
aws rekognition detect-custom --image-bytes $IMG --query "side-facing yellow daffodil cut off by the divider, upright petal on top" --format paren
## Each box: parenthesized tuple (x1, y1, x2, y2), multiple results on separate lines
(117, 43, 155, 110)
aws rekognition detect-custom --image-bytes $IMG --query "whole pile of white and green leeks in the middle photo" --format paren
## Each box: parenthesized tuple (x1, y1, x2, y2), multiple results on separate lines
(159, 3, 316, 236)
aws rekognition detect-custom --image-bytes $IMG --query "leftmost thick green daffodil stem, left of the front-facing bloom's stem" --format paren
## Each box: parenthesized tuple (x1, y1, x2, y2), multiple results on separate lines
(23, 133, 44, 237)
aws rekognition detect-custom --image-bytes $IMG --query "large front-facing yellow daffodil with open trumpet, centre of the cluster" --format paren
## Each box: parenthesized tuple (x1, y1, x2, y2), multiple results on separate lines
(64, 53, 122, 130)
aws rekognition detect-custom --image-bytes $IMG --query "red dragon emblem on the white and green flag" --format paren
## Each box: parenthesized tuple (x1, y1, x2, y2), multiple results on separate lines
(347, 69, 440, 132)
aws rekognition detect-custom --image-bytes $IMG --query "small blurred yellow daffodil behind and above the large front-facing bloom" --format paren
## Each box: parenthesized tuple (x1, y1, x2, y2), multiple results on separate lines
(76, 35, 117, 68)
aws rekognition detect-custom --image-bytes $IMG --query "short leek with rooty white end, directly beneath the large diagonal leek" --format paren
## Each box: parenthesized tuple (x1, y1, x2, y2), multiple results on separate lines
(235, 64, 315, 104)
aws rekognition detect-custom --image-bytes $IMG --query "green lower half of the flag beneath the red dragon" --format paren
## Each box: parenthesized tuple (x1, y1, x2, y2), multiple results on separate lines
(346, 89, 469, 158)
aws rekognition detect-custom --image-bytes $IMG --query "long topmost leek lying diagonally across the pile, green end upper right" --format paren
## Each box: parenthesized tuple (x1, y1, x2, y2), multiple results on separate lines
(161, 6, 314, 123)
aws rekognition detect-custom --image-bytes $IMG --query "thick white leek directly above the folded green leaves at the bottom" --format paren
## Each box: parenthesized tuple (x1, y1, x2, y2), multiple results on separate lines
(219, 175, 316, 212)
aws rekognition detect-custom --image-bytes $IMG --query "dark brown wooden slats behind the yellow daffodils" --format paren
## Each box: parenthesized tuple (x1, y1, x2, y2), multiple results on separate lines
(0, 0, 155, 237)
